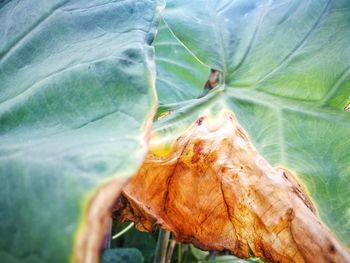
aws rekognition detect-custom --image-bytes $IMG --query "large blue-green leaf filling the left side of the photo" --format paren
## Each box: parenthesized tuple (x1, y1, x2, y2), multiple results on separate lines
(0, 0, 161, 263)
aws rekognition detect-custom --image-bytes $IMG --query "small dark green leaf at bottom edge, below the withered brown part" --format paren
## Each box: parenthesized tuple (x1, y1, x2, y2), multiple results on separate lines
(101, 248, 144, 263)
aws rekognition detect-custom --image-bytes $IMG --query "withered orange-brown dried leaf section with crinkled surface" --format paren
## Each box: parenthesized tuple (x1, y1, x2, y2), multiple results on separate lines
(113, 113, 350, 263)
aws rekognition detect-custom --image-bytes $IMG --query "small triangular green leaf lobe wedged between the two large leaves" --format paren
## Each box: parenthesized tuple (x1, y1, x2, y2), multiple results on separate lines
(153, 21, 209, 105)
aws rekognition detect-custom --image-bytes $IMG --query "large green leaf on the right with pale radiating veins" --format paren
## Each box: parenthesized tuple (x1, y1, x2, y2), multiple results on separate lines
(155, 0, 350, 246)
